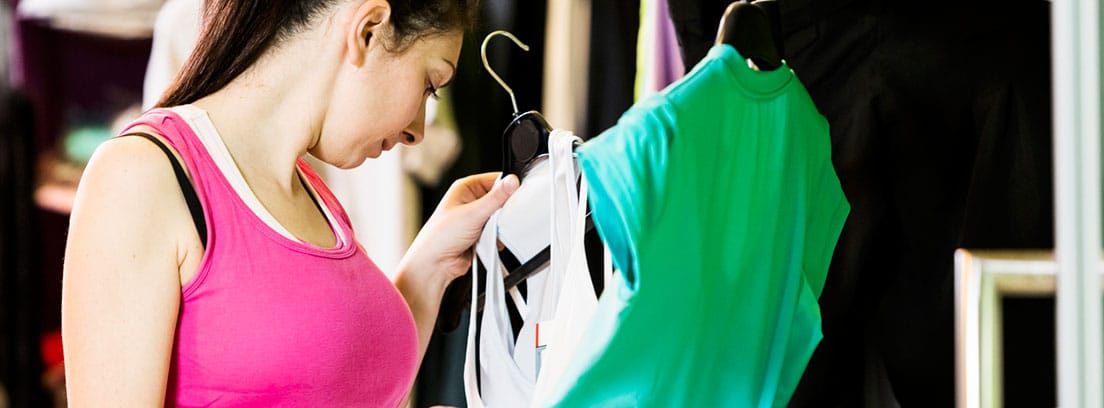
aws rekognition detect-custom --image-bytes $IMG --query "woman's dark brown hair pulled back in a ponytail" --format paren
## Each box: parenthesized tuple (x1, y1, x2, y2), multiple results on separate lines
(157, 0, 478, 107)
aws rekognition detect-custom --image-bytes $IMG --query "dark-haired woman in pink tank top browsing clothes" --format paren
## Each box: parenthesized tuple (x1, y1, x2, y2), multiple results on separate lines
(62, 0, 518, 407)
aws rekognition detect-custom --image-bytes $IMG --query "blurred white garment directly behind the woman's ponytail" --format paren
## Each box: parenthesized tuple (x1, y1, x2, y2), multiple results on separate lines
(141, 0, 203, 110)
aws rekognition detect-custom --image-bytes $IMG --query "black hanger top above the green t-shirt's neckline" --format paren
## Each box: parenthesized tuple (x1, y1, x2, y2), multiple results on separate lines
(716, 0, 784, 71)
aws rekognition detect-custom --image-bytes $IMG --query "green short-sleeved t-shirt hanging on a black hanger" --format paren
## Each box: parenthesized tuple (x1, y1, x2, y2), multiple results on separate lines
(548, 45, 850, 407)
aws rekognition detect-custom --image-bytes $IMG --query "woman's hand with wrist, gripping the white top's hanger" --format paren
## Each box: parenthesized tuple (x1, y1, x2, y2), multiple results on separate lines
(400, 173, 518, 290)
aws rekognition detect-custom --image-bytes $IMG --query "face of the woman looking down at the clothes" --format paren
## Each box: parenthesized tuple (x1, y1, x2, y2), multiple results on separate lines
(309, 25, 464, 169)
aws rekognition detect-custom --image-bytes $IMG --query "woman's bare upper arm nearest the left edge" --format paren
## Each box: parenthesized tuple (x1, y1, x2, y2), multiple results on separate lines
(62, 137, 195, 407)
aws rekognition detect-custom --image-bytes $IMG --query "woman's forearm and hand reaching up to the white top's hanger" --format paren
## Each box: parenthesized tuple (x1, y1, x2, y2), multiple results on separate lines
(395, 173, 518, 365)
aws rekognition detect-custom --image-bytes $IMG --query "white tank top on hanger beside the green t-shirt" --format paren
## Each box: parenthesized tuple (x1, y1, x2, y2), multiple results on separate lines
(464, 131, 597, 408)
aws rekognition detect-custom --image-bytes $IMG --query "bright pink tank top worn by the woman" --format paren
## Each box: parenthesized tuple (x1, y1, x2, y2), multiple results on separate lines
(123, 109, 417, 407)
